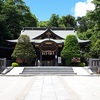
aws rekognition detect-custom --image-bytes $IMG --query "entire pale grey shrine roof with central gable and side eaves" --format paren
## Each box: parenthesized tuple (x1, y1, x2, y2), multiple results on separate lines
(8, 27, 90, 43)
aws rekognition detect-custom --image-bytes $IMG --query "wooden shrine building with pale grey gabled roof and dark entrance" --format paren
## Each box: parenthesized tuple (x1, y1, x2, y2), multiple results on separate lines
(8, 27, 90, 66)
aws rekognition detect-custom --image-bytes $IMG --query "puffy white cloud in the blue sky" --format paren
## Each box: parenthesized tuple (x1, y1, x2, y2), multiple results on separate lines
(74, 0, 95, 17)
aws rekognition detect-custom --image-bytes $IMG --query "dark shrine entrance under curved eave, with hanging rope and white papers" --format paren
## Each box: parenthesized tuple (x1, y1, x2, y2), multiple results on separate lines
(39, 40, 58, 66)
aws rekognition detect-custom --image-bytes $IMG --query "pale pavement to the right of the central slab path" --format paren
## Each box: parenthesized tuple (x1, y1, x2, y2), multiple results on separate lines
(63, 76, 100, 100)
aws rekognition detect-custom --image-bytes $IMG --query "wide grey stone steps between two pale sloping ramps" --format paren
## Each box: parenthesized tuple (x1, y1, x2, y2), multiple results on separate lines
(21, 66, 77, 75)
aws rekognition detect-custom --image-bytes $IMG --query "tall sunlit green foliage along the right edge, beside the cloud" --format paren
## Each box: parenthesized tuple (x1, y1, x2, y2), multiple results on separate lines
(78, 0, 100, 58)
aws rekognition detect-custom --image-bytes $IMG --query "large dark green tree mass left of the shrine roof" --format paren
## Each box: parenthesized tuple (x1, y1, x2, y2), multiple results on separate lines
(0, 0, 37, 46)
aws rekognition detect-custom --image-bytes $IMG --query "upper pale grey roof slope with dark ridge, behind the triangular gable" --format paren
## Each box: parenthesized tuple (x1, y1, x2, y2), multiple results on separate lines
(21, 28, 76, 39)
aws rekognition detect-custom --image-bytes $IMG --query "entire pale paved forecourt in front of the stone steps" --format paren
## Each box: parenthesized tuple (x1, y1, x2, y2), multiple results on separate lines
(0, 69, 100, 100)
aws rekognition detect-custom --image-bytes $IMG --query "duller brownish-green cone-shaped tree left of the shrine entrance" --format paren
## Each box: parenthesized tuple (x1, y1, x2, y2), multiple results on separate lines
(11, 35, 36, 65)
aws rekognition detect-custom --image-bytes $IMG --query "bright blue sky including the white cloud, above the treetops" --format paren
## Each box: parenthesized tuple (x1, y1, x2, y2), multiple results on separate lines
(24, 0, 95, 21)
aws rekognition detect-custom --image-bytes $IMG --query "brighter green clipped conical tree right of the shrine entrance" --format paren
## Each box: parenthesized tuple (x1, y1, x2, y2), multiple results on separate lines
(61, 35, 81, 65)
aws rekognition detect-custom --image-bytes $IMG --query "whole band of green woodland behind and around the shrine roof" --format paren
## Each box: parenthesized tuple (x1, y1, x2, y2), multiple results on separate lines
(0, 0, 100, 60)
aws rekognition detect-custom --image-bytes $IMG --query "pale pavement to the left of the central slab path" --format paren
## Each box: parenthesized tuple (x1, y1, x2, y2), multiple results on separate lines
(0, 76, 34, 100)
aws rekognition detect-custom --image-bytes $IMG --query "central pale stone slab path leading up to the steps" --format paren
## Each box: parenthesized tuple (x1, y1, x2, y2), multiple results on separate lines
(25, 76, 72, 100)
